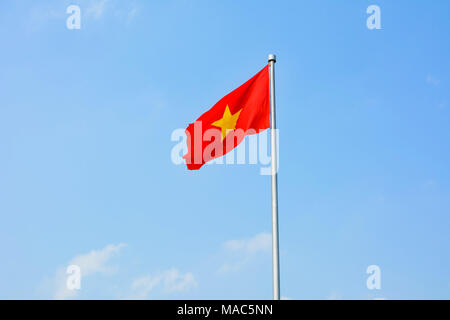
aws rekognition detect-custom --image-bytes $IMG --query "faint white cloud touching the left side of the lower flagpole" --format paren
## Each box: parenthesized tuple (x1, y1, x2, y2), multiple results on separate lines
(218, 232, 272, 273)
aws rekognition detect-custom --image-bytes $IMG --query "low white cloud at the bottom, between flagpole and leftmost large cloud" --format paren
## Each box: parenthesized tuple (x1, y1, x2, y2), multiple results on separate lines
(131, 268, 198, 299)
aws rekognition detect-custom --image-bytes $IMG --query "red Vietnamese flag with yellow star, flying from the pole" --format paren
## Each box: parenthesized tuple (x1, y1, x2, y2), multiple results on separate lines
(183, 65, 270, 170)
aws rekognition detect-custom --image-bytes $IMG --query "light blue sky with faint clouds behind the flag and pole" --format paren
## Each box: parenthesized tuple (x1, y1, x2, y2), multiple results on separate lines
(0, 0, 450, 299)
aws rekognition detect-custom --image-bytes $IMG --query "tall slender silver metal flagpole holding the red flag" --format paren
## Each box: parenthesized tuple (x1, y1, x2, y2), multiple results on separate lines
(269, 54, 280, 300)
